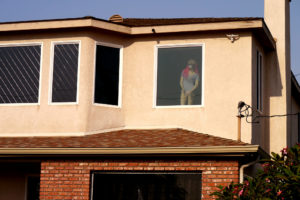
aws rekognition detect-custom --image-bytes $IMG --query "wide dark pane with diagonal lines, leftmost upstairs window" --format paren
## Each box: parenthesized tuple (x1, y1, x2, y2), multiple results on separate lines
(0, 46, 41, 103)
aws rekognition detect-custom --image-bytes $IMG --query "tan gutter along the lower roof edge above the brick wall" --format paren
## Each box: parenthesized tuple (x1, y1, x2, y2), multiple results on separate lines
(0, 145, 259, 157)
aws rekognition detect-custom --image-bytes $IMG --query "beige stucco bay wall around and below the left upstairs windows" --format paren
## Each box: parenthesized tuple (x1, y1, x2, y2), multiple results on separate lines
(0, 31, 123, 136)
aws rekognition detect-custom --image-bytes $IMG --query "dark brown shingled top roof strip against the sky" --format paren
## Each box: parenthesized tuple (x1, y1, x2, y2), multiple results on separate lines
(117, 17, 262, 27)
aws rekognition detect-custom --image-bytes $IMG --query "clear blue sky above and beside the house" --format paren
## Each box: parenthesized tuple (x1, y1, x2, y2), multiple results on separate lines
(0, 0, 300, 82)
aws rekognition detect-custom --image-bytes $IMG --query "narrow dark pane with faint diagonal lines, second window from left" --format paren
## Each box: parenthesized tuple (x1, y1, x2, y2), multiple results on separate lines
(52, 44, 79, 102)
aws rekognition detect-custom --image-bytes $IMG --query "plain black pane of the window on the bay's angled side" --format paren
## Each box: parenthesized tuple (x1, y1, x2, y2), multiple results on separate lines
(94, 45, 120, 105)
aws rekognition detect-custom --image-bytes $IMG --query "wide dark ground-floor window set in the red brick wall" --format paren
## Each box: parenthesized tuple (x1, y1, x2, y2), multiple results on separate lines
(92, 172, 201, 200)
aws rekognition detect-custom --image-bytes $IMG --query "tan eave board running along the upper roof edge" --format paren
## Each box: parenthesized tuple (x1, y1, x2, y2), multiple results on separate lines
(0, 17, 276, 49)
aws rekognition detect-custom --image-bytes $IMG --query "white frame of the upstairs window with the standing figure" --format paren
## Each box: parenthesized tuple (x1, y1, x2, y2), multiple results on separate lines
(153, 43, 205, 108)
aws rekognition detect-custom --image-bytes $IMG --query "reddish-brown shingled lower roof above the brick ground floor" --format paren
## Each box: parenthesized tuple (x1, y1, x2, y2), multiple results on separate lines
(0, 129, 248, 148)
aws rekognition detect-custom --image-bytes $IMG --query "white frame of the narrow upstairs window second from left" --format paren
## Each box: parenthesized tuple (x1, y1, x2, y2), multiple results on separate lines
(48, 40, 81, 105)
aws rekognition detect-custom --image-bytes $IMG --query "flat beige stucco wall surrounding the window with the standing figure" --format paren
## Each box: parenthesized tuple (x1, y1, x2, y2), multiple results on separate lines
(123, 33, 251, 140)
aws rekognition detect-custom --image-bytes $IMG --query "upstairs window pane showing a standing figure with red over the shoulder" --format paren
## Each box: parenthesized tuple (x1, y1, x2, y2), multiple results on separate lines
(156, 45, 203, 106)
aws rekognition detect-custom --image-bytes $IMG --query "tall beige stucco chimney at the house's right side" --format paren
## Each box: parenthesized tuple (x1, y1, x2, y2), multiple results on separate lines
(265, 0, 291, 152)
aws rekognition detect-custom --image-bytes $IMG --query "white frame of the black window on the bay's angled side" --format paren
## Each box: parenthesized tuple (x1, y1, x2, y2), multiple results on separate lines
(92, 41, 124, 108)
